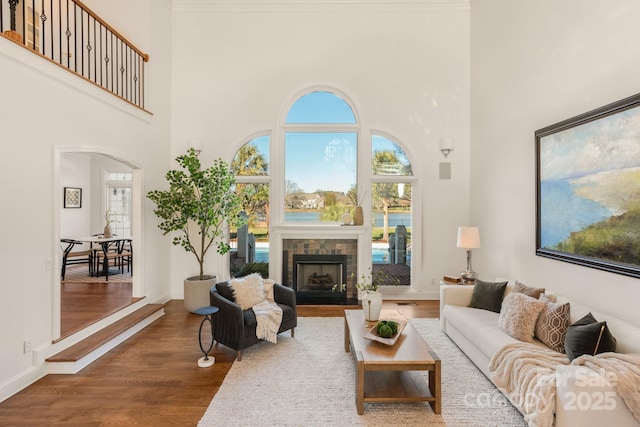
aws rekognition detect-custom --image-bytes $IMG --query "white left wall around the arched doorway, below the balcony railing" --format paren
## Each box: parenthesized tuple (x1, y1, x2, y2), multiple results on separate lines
(0, 0, 171, 400)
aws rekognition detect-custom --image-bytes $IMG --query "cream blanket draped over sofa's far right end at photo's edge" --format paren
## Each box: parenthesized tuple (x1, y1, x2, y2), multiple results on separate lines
(571, 353, 640, 422)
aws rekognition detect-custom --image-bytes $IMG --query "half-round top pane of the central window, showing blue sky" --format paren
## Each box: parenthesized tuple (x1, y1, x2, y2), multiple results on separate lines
(286, 92, 356, 123)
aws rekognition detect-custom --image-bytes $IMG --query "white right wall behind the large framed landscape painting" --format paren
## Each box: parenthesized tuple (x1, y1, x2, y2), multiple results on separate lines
(471, 0, 640, 323)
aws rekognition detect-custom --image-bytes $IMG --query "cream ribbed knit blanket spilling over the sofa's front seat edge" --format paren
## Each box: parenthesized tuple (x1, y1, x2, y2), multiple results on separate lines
(489, 342, 569, 427)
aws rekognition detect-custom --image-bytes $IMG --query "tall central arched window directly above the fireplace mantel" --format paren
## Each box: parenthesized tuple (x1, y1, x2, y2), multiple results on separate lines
(284, 91, 359, 222)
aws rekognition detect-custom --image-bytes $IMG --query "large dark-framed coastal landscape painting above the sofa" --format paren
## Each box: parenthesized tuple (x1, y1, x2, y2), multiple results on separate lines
(535, 94, 640, 277)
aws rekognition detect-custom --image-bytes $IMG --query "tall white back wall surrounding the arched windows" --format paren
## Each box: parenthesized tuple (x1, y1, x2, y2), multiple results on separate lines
(171, 0, 469, 298)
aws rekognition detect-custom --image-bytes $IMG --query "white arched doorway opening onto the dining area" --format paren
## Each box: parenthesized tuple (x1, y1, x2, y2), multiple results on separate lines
(52, 147, 144, 339)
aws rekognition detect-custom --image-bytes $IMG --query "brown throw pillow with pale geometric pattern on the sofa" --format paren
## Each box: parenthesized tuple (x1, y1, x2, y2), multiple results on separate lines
(535, 294, 571, 353)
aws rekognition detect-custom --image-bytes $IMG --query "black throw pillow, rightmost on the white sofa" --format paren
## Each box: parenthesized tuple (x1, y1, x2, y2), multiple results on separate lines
(564, 313, 616, 360)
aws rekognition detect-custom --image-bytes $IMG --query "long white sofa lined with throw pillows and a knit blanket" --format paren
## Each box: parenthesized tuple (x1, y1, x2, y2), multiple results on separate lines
(440, 283, 640, 427)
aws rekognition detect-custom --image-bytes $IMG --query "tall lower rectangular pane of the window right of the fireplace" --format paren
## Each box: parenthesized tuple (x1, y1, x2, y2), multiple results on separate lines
(371, 182, 411, 285)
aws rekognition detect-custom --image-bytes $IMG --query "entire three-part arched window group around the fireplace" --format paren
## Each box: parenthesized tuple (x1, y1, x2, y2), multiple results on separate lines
(231, 90, 416, 285)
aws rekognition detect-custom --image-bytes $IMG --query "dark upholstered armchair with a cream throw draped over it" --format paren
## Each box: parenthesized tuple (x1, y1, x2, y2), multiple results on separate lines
(210, 282, 298, 361)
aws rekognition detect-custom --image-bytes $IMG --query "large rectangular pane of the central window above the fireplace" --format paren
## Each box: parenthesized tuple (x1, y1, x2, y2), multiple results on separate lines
(285, 132, 357, 222)
